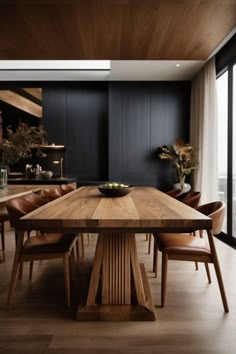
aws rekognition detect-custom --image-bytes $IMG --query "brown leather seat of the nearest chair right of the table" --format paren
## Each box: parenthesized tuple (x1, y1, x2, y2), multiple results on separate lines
(158, 234, 211, 255)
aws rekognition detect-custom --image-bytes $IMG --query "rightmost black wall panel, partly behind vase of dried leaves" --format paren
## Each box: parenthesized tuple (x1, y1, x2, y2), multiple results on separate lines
(151, 82, 190, 188)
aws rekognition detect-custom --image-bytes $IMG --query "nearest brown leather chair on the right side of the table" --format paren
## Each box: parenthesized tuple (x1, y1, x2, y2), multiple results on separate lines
(154, 201, 229, 312)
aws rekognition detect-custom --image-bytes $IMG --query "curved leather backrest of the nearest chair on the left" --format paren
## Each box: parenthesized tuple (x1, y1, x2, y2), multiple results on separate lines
(6, 197, 38, 228)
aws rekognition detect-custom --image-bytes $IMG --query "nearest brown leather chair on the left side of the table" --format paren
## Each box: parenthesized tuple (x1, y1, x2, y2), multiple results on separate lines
(6, 197, 79, 309)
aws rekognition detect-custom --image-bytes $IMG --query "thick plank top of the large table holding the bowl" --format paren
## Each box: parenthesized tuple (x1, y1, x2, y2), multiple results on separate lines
(18, 186, 212, 233)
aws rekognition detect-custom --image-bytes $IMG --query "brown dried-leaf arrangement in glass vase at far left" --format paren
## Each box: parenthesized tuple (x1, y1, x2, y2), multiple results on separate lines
(0, 122, 46, 188)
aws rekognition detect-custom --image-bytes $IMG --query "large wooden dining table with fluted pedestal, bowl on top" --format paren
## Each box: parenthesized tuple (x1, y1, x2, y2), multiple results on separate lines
(10, 186, 212, 321)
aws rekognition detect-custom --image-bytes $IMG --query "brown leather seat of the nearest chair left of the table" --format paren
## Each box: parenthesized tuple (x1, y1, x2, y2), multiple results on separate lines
(23, 233, 78, 254)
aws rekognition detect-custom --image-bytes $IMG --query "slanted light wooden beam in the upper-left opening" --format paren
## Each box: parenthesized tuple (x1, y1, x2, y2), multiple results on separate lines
(0, 90, 42, 118)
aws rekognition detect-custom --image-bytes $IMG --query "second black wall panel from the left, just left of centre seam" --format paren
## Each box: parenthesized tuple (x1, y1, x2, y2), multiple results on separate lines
(66, 83, 108, 180)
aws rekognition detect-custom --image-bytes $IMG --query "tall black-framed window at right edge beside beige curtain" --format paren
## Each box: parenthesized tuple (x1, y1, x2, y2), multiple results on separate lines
(217, 63, 236, 246)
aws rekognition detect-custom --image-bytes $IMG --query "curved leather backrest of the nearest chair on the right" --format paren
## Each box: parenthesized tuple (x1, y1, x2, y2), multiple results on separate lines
(197, 201, 226, 235)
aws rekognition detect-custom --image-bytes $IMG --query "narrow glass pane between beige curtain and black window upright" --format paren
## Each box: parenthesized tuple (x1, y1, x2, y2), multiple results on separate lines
(217, 71, 228, 233)
